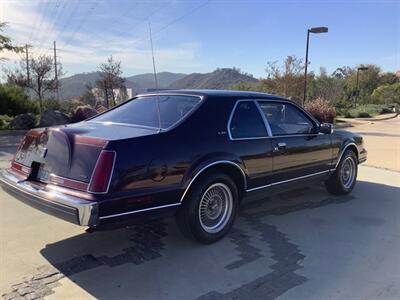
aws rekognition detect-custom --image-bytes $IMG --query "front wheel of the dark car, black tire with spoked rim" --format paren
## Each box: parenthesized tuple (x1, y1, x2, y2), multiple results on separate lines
(325, 150, 358, 195)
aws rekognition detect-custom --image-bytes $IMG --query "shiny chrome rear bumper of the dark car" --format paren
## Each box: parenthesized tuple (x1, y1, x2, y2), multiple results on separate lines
(0, 170, 98, 226)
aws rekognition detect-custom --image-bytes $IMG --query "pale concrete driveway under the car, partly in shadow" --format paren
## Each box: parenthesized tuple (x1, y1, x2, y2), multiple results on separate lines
(0, 119, 400, 299)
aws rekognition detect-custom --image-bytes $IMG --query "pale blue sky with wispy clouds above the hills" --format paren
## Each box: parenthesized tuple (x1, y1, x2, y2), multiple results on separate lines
(0, 0, 400, 78)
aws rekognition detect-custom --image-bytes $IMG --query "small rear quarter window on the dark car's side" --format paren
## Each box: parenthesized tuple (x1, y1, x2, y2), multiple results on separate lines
(229, 101, 268, 139)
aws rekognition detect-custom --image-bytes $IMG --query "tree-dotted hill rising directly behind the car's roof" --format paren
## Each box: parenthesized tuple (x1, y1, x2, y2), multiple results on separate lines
(169, 68, 258, 89)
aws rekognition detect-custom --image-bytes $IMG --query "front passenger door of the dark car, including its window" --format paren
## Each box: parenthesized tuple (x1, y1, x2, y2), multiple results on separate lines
(258, 101, 332, 183)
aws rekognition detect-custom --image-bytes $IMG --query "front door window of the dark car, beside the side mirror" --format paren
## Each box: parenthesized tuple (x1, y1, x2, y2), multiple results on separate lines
(259, 101, 314, 136)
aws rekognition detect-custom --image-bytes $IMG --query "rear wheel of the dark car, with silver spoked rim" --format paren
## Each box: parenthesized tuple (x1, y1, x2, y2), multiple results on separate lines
(176, 173, 239, 244)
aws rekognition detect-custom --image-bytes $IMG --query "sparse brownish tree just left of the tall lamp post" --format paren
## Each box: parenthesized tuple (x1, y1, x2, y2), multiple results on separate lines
(262, 55, 304, 102)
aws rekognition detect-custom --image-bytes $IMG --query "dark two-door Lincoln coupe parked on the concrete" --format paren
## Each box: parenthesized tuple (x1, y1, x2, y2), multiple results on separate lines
(0, 90, 367, 243)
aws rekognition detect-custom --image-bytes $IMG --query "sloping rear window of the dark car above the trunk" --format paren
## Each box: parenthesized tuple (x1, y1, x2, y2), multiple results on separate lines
(91, 95, 200, 129)
